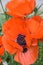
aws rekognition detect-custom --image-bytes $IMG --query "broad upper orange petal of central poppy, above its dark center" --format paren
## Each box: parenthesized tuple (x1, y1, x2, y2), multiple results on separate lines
(2, 18, 25, 40)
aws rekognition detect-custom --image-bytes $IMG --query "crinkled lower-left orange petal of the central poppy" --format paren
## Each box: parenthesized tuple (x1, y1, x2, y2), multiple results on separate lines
(2, 36, 22, 54)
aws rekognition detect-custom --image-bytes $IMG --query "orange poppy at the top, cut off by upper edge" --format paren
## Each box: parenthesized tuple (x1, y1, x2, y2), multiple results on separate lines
(6, 0, 36, 17)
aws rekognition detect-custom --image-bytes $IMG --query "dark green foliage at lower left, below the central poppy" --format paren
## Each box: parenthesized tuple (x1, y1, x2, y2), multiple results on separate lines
(1, 51, 20, 65)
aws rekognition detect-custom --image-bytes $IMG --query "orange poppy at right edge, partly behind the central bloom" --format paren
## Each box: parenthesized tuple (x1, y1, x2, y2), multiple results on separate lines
(26, 16, 43, 39)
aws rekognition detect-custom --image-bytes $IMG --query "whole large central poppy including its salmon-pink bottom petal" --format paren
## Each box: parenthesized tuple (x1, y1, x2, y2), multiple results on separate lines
(2, 18, 38, 65)
